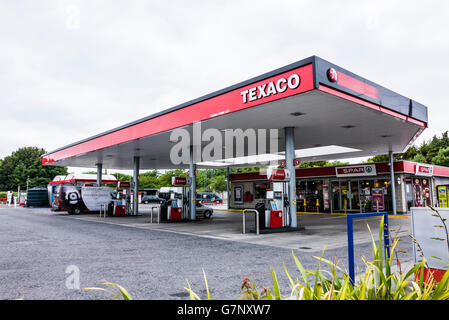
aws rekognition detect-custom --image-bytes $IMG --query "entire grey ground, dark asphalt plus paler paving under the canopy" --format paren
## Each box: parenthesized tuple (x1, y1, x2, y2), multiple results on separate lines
(0, 207, 413, 300)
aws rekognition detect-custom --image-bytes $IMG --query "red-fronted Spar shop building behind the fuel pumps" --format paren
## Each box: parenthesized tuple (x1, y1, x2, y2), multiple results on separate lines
(230, 161, 449, 214)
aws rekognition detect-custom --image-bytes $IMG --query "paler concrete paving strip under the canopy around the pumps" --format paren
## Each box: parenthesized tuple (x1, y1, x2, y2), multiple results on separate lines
(61, 205, 411, 252)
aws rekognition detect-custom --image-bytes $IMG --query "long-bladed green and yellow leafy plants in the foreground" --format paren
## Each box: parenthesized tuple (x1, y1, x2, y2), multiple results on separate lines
(186, 218, 449, 300)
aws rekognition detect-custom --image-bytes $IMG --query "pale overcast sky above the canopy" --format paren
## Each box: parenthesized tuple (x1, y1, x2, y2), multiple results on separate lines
(0, 0, 449, 172)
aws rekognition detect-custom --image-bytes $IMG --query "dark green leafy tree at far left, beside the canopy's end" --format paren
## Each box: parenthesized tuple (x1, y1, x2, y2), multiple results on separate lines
(0, 147, 67, 190)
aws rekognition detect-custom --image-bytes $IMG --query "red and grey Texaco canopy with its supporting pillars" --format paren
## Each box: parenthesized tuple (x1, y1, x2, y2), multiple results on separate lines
(41, 56, 428, 228)
